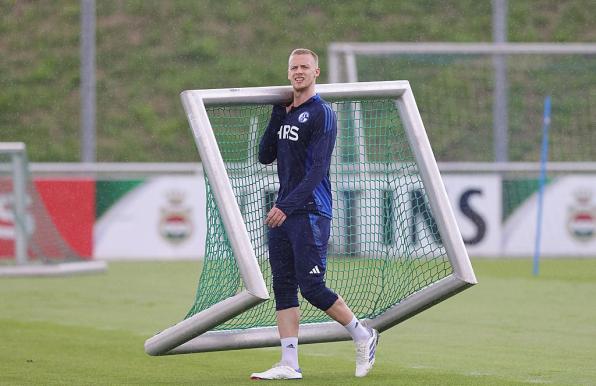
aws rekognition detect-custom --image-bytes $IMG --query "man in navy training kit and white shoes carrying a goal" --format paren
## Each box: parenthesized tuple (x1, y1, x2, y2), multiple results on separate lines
(251, 48, 379, 379)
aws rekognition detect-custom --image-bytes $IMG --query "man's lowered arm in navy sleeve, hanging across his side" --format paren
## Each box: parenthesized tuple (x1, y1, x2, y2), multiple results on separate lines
(275, 105, 337, 216)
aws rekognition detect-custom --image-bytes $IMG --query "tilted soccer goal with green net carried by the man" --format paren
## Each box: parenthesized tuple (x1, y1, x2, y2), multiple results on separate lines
(145, 81, 476, 355)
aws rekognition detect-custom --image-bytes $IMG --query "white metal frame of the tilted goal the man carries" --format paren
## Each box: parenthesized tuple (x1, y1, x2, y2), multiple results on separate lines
(145, 81, 477, 355)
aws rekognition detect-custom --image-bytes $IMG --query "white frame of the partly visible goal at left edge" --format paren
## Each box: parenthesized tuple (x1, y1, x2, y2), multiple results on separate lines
(0, 142, 107, 278)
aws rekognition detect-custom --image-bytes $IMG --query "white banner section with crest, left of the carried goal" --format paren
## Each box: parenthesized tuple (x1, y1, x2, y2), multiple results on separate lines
(94, 176, 206, 260)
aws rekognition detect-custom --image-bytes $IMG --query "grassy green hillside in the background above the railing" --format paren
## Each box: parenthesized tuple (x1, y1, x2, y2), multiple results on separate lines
(0, 0, 596, 162)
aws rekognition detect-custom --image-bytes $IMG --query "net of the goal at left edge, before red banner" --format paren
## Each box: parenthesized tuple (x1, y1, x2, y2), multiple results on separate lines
(0, 151, 83, 265)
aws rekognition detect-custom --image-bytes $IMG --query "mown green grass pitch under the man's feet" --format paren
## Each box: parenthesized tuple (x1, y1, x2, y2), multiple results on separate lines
(0, 259, 596, 385)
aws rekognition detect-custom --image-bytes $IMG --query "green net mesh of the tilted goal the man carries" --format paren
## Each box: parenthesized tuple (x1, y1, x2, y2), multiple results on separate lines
(187, 99, 452, 329)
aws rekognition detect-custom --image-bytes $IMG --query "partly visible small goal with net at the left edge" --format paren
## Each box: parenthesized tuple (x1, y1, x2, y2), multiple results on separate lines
(0, 142, 106, 277)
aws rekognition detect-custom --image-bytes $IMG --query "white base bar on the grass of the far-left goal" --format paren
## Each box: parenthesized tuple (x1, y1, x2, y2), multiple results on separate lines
(0, 260, 108, 277)
